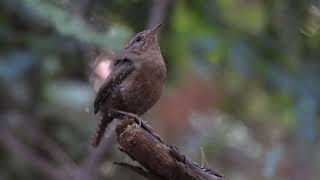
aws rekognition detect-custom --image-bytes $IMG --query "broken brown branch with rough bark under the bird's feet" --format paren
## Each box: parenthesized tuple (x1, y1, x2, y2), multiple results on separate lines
(116, 117, 223, 180)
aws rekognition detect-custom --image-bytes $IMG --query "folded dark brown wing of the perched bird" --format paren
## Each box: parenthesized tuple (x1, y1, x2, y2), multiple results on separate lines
(94, 58, 135, 114)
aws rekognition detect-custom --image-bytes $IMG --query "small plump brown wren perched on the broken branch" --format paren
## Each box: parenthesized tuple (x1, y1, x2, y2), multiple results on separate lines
(92, 24, 166, 147)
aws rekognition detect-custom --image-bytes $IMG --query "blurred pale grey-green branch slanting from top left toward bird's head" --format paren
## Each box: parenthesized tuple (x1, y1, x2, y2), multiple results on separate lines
(22, 0, 128, 48)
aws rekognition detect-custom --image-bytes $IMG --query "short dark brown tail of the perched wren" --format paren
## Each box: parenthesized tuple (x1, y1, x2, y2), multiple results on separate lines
(91, 113, 114, 147)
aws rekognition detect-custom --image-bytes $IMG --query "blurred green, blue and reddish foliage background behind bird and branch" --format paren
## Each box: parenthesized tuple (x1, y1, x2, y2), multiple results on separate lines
(0, 0, 320, 180)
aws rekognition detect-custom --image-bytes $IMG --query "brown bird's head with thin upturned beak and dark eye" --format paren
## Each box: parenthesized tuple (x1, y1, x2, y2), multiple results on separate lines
(125, 24, 161, 54)
